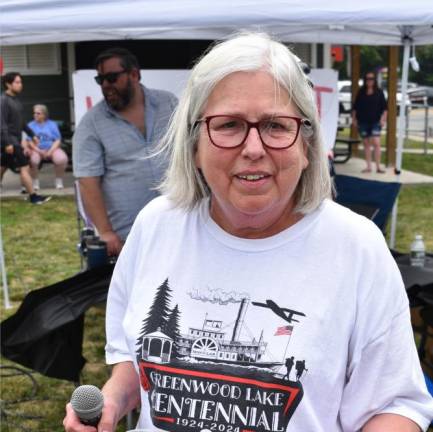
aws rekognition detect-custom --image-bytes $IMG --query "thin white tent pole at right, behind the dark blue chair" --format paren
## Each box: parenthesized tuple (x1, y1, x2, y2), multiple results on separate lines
(389, 36, 410, 249)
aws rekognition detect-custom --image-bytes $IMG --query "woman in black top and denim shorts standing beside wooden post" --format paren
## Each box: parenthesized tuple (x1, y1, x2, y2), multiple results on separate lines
(352, 72, 387, 173)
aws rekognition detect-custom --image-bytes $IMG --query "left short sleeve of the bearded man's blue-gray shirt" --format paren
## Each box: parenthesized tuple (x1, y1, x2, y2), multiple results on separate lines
(72, 115, 105, 178)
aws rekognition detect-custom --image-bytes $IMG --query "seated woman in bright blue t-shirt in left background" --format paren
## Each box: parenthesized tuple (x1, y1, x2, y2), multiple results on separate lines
(27, 105, 68, 190)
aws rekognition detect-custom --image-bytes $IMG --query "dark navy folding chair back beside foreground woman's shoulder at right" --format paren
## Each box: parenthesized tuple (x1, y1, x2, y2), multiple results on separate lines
(334, 175, 401, 232)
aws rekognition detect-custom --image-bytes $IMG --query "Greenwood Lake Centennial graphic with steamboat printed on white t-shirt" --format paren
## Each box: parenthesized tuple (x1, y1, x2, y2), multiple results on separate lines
(136, 279, 308, 432)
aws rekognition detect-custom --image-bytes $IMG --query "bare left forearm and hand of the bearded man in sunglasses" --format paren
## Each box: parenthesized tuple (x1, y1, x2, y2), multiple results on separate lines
(79, 177, 123, 256)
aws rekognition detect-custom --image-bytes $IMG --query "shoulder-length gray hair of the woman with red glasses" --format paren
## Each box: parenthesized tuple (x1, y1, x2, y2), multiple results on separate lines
(159, 33, 331, 214)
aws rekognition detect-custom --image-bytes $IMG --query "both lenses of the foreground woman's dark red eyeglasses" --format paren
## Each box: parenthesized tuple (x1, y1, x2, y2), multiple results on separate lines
(208, 116, 300, 149)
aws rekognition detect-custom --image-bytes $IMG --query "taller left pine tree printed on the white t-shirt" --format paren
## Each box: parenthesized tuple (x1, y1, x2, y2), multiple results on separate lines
(137, 278, 171, 355)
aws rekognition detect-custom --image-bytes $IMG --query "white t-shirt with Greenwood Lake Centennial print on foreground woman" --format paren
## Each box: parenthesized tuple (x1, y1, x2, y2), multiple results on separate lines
(106, 197, 433, 432)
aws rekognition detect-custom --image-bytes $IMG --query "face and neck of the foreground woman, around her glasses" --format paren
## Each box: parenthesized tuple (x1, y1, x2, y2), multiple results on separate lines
(195, 71, 308, 238)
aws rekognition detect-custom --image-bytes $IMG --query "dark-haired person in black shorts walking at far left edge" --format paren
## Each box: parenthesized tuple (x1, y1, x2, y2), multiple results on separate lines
(0, 72, 51, 204)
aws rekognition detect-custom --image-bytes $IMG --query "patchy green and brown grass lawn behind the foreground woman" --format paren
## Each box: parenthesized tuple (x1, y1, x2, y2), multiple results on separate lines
(0, 155, 433, 432)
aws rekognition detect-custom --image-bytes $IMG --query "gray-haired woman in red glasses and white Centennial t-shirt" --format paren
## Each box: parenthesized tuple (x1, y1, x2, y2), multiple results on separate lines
(64, 34, 433, 432)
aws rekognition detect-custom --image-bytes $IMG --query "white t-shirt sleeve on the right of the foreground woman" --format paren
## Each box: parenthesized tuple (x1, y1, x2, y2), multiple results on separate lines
(340, 238, 433, 431)
